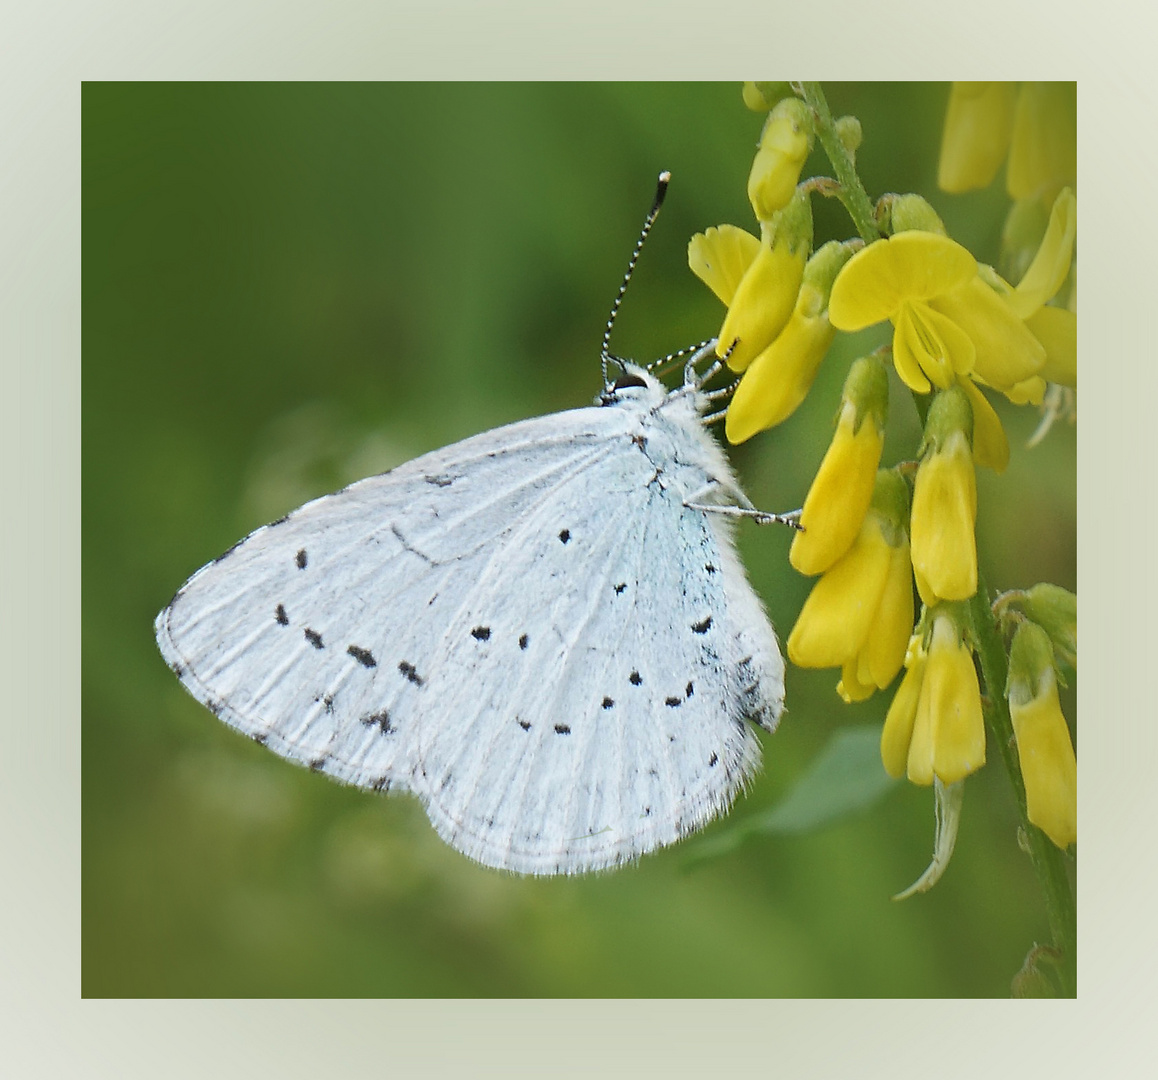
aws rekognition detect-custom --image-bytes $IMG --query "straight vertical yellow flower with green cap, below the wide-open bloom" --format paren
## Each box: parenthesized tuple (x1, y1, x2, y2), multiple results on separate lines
(911, 387, 977, 604)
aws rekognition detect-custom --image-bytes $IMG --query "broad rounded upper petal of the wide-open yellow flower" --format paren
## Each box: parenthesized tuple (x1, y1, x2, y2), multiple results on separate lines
(828, 236, 977, 331)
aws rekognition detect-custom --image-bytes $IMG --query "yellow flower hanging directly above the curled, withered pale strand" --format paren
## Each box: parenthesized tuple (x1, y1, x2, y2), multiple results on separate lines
(903, 608, 985, 785)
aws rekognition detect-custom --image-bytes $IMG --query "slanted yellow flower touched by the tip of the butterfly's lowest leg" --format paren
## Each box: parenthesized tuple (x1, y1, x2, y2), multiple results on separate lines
(789, 357, 888, 575)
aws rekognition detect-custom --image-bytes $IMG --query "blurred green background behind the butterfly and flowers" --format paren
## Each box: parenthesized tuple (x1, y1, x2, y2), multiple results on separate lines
(82, 83, 1076, 997)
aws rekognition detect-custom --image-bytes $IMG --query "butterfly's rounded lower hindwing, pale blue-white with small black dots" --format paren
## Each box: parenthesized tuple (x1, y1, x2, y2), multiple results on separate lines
(419, 458, 773, 873)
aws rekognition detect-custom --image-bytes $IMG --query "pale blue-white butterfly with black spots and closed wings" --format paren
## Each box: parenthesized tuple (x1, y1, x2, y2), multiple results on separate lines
(156, 366, 783, 874)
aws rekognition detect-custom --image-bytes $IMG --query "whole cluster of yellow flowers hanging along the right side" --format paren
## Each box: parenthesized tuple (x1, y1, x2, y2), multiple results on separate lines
(688, 83, 1077, 859)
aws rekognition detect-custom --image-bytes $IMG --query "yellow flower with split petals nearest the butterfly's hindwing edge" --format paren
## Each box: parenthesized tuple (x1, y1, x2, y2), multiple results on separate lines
(787, 469, 913, 700)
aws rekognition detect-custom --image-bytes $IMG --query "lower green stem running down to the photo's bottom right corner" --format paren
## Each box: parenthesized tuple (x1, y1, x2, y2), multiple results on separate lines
(969, 581, 1077, 997)
